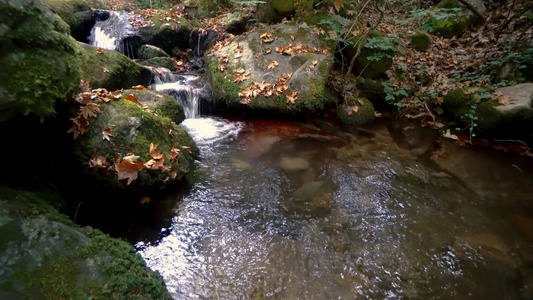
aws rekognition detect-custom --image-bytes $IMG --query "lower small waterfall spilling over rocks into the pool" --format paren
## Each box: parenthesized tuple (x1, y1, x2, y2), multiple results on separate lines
(152, 74, 200, 119)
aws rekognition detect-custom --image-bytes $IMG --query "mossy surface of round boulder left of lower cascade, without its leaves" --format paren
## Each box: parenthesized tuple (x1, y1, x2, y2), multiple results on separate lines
(74, 100, 199, 193)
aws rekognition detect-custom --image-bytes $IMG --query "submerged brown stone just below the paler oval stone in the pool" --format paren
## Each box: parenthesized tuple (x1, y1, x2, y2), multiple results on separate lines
(286, 181, 333, 217)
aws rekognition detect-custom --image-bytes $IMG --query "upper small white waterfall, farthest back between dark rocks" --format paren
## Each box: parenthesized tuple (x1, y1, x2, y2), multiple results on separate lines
(87, 11, 135, 58)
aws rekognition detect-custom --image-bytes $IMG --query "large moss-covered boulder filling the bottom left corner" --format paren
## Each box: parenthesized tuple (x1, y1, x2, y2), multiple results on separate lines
(0, 187, 170, 299)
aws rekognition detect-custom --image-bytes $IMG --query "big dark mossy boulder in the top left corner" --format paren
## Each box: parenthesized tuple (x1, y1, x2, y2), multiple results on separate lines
(0, 0, 82, 121)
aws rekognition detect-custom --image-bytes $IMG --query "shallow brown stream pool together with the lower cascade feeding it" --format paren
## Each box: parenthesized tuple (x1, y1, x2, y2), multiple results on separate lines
(89, 17, 533, 299)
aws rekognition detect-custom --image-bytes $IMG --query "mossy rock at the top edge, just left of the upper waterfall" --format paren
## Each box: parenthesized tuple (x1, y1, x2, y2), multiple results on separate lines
(42, 0, 104, 41)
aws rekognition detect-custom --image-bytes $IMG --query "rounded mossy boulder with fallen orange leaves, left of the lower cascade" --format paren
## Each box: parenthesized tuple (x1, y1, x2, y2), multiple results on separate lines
(74, 98, 199, 194)
